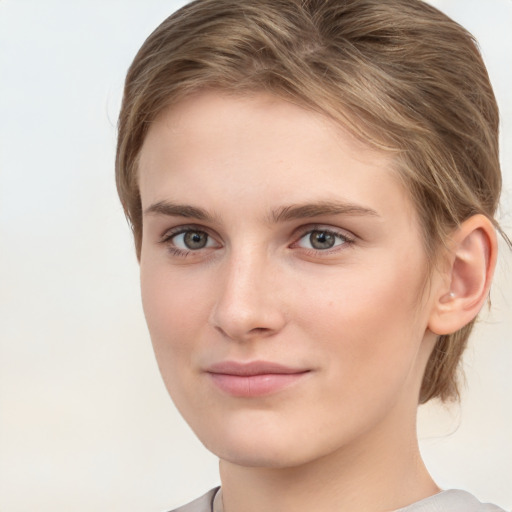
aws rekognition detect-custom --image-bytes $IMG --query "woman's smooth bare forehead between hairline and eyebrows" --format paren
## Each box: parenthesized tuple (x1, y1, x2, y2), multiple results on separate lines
(139, 92, 412, 226)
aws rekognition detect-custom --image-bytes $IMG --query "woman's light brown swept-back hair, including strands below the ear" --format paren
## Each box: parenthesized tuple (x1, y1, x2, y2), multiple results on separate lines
(116, 0, 505, 403)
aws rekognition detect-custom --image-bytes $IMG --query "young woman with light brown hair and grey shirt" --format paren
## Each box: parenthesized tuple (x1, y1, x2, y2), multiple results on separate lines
(116, 0, 508, 512)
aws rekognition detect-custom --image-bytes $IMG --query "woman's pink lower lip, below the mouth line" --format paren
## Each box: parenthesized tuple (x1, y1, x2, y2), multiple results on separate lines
(209, 372, 309, 397)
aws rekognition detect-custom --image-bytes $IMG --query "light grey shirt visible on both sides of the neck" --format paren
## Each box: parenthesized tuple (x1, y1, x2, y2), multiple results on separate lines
(171, 487, 505, 512)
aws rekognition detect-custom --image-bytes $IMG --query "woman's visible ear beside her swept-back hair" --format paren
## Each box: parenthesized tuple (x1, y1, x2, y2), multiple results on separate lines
(428, 215, 498, 335)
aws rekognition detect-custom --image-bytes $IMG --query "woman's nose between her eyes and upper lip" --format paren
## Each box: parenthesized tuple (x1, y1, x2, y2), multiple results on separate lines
(210, 250, 286, 342)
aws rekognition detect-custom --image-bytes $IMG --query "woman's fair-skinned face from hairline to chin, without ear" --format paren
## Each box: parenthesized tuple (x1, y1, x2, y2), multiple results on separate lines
(139, 92, 438, 467)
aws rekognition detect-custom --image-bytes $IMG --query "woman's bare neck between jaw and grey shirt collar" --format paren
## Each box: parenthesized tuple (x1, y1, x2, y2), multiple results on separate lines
(220, 408, 439, 512)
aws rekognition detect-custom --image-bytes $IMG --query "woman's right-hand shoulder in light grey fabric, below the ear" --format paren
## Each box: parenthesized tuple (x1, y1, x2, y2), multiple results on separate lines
(396, 489, 505, 512)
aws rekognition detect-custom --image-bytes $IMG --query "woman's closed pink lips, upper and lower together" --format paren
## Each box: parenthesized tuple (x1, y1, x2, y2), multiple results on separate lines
(206, 361, 311, 398)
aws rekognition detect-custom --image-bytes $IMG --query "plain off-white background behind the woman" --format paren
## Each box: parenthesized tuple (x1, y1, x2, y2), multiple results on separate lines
(0, 0, 512, 512)
